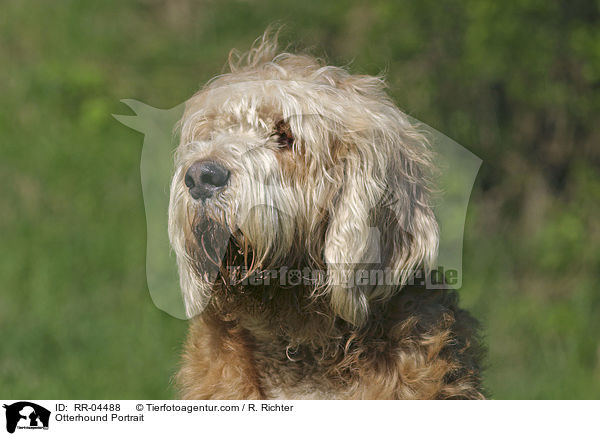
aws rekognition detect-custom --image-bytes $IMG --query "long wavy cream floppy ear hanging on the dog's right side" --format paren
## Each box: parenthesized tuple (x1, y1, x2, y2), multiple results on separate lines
(324, 117, 438, 326)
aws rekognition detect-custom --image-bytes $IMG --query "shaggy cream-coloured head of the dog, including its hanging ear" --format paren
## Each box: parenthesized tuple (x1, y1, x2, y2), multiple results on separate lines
(169, 41, 438, 325)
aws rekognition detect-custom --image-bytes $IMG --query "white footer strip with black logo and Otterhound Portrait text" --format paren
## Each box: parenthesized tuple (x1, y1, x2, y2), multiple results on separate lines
(0, 400, 600, 436)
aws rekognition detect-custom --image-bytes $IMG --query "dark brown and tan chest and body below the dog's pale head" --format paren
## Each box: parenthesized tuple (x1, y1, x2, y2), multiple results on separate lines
(177, 285, 483, 399)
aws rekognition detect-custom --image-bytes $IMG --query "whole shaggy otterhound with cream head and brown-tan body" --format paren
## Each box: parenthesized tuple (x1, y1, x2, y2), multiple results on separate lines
(169, 35, 483, 399)
